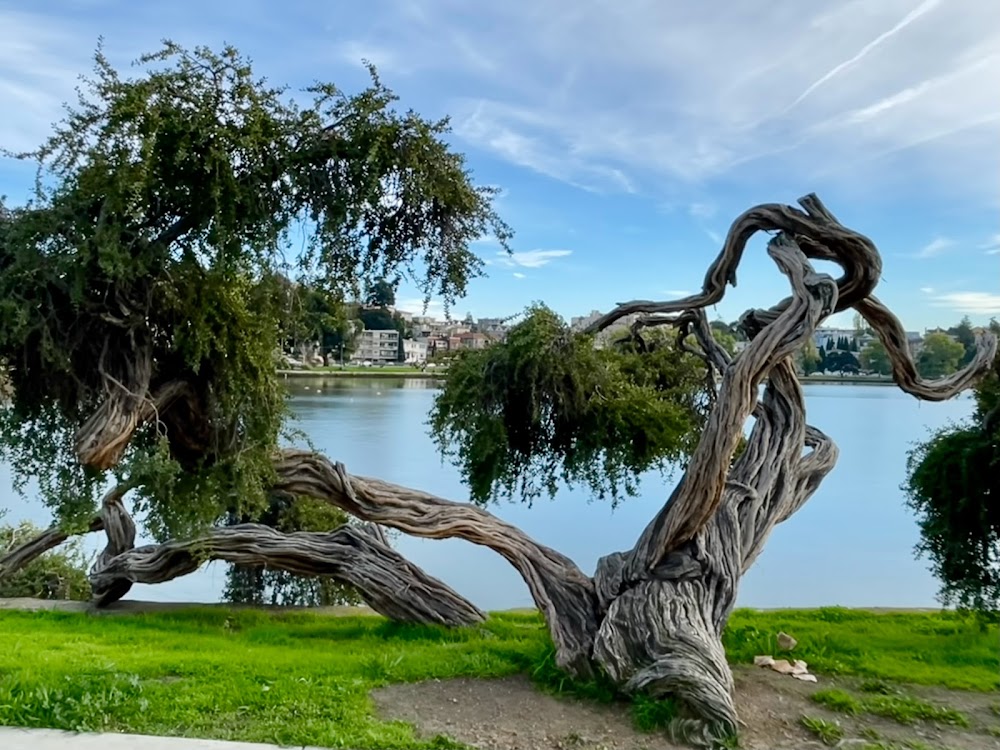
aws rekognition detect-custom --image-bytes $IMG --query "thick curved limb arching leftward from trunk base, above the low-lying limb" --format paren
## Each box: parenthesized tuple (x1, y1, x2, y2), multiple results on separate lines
(276, 450, 598, 675)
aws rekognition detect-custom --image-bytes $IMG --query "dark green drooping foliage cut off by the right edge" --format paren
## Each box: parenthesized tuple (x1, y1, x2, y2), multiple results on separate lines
(904, 321, 1000, 612)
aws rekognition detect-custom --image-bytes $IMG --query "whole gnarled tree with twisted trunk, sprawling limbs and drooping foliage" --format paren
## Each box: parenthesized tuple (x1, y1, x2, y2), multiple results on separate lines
(0, 45, 996, 743)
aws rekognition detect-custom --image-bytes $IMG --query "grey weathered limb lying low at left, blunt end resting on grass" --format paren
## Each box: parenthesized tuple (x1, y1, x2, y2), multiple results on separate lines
(90, 524, 485, 625)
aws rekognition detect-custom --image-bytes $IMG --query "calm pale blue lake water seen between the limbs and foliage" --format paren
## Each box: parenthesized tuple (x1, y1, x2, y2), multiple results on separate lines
(0, 380, 972, 609)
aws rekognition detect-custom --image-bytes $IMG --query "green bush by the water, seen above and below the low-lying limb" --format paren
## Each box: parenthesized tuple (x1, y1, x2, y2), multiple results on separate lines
(222, 497, 361, 607)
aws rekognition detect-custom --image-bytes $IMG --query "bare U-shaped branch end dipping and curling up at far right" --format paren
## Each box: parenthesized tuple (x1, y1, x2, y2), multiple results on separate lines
(855, 296, 997, 401)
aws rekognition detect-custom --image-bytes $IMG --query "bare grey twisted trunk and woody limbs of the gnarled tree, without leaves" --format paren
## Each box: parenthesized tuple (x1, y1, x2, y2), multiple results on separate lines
(0, 195, 997, 745)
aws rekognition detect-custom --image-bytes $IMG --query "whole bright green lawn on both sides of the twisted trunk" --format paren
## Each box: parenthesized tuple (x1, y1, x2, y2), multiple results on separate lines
(0, 609, 1000, 750)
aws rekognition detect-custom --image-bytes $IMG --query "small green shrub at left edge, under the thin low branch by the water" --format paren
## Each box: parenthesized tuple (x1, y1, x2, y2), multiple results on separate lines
(0, 523, 90, 604)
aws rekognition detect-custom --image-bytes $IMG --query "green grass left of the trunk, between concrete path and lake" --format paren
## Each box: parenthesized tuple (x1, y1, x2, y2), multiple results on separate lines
(0, 609, 548, 750)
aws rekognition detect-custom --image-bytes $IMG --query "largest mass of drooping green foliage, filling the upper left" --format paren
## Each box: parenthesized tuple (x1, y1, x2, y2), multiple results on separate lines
(0, 42, 510, 535)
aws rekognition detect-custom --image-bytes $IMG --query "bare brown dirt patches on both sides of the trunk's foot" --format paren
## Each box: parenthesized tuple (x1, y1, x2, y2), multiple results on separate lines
(372, 668, 1000, 750)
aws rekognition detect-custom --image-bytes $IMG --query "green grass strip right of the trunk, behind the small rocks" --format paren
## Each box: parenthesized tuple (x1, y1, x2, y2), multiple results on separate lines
(723, 607, 1000, 692)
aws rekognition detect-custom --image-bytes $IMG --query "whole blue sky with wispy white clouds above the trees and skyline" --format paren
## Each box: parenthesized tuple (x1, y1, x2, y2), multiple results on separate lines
(0, 0, 1000, 330)
